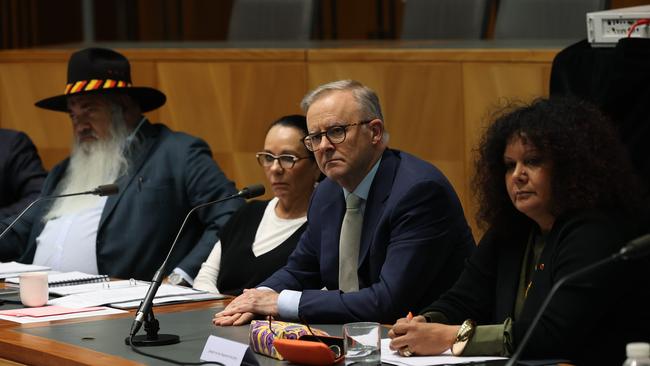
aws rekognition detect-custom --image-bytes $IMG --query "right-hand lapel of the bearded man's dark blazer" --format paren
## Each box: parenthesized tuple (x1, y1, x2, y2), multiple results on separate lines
(99, 121, 158, 230)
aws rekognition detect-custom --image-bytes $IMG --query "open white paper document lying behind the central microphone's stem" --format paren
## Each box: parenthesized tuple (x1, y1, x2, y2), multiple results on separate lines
(47, 281, 208, 308)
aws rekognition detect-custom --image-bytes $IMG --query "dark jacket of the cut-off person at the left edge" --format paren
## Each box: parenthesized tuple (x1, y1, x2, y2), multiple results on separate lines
(0, 129, 47, 219)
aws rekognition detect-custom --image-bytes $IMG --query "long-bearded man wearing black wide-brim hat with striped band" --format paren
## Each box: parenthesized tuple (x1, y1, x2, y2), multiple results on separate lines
(0, 48, 242, 284)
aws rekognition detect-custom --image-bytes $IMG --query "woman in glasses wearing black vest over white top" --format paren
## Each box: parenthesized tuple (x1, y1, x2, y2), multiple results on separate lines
(194, 115, 321, 295)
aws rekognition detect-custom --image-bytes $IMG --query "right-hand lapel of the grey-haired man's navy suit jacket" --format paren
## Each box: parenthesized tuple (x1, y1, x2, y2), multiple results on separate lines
(358, 149, 400, 268)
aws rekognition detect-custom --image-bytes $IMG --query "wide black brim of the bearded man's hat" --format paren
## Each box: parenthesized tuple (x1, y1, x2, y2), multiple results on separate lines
(34, 86, 167, 113)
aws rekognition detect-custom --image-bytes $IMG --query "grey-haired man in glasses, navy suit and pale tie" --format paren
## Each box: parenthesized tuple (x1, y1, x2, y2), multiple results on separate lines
(213, 80, 474, 325)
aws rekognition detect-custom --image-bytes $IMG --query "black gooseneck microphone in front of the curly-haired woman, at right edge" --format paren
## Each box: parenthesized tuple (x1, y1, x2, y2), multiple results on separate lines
(506, 234, 650, 366)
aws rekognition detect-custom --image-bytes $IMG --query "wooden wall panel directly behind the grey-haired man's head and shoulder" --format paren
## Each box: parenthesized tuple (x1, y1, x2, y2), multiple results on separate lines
(309, 61, 466, 213)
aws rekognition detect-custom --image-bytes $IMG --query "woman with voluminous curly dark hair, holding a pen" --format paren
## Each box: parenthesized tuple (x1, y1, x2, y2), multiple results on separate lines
(389, 99, 650, 365)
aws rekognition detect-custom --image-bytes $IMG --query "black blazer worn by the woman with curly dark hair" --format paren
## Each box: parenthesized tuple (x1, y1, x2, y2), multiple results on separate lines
(423, 211, 650, 365)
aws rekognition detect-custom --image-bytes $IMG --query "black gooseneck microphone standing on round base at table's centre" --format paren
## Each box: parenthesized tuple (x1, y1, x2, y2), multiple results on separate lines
(124, 184, 265, 346)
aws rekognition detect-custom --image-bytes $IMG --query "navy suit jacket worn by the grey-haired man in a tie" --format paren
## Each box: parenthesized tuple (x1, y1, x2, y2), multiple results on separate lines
(260, 150, 474, 323)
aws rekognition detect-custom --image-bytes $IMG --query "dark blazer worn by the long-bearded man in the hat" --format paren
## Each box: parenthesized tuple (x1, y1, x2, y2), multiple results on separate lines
(0, 122, 243, 280)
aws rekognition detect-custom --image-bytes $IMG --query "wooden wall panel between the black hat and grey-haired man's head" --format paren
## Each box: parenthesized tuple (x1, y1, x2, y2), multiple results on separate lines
(157, 62, 307, 196)
